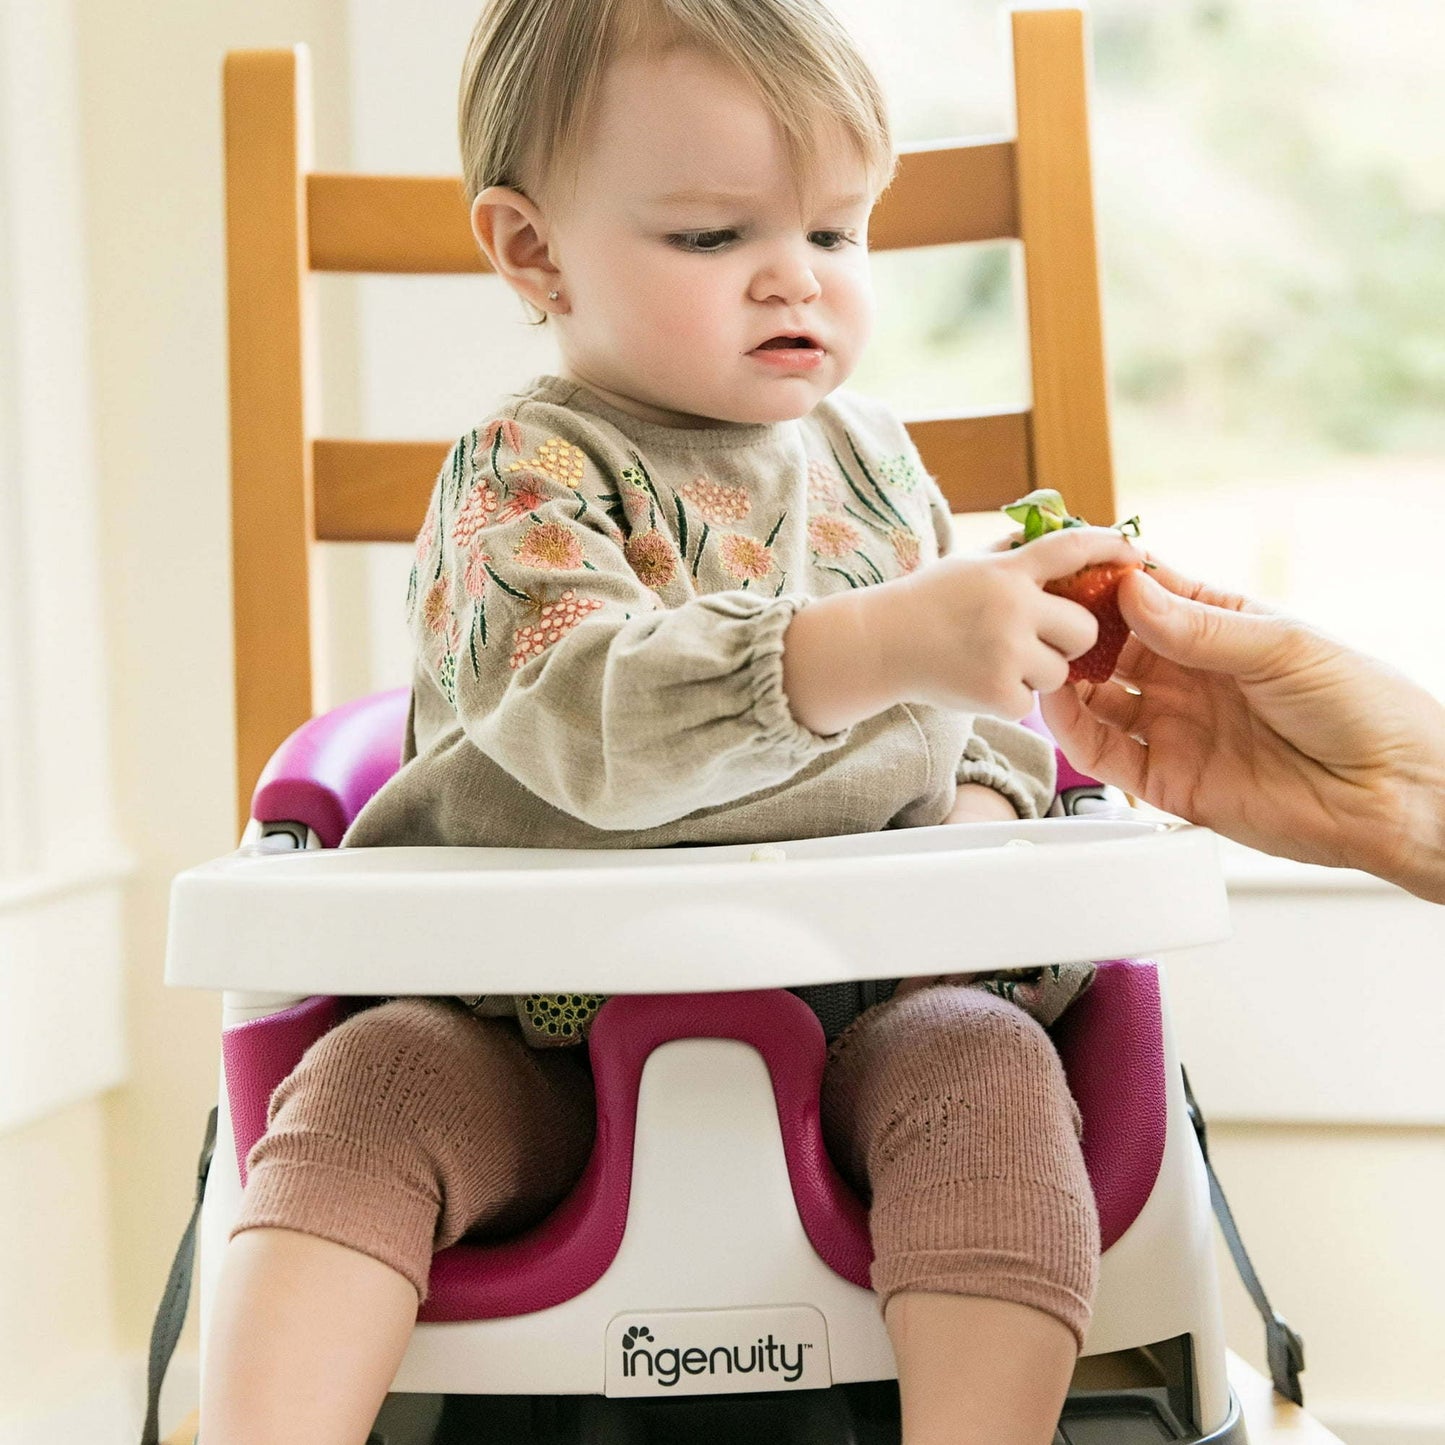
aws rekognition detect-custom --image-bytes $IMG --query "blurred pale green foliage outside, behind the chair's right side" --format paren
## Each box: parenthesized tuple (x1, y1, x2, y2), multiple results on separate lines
(857, 0, 1445, 493)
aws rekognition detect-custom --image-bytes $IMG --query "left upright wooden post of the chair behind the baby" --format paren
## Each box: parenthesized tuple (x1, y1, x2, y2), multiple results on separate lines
(224, 45, 318, 827)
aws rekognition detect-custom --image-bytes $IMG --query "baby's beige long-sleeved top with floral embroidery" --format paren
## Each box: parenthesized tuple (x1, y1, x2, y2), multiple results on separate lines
(345, 376, 1087, 1043)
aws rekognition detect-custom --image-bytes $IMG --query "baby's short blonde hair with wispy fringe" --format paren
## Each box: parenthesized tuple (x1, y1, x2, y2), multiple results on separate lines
(458, 0, 894, 204)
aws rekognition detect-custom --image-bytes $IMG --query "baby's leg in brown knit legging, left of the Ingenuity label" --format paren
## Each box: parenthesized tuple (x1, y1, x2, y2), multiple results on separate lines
(201, 998, 594, 1445)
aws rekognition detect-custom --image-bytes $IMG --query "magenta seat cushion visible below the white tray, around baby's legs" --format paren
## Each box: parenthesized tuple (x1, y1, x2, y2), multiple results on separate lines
(223, 961, 1166, 1321)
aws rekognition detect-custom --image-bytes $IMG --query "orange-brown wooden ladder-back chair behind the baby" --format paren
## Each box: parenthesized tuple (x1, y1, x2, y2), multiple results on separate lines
(225, 9, 1114, 827)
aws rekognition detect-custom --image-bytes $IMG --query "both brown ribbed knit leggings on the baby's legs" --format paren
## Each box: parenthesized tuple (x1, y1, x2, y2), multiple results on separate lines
(233, 984, 1098, 1341)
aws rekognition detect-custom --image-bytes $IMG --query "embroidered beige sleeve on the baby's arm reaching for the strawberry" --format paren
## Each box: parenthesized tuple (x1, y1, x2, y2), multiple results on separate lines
(409, 409, 848, 829)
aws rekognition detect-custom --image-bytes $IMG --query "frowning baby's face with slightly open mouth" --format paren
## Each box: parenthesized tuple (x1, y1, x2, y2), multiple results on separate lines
(551, 49, 873, 426)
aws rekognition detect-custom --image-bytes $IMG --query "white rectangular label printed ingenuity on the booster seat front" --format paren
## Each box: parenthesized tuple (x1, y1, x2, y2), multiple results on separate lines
(605, 1305, 832, 1396)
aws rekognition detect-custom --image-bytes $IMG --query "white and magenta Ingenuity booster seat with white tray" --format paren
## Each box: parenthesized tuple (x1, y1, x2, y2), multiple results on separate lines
(168, 691, 1243, 1445)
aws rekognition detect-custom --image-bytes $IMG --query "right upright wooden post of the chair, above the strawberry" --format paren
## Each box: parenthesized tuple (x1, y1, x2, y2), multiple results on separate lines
(1012, 10, 1117, 526)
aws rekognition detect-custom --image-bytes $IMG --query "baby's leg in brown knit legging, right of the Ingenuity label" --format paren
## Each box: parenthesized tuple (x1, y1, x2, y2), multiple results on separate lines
(822, 984, 1098, 1445)
